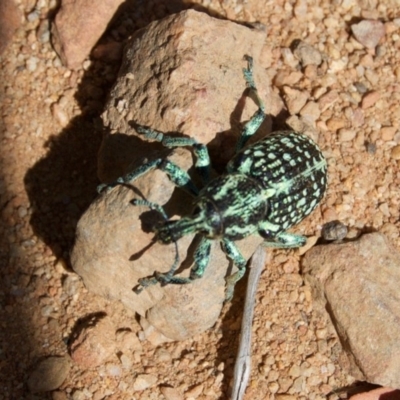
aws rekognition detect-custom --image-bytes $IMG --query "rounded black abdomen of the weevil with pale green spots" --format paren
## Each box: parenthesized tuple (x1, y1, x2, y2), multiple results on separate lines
(227, 131, 327, 231)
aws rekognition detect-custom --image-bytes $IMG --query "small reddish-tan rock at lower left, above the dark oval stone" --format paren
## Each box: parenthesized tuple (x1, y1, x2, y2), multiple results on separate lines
(70, 317, 115, 368)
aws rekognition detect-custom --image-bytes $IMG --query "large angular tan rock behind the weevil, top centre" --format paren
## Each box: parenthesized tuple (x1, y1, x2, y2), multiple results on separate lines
(99, 10, 282, 181)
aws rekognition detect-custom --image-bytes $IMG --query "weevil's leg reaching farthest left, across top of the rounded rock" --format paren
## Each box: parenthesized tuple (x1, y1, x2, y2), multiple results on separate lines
(97, 158, 199, 196)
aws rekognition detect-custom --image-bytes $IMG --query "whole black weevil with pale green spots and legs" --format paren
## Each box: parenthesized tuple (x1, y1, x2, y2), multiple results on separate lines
(98, 56, 327, 299)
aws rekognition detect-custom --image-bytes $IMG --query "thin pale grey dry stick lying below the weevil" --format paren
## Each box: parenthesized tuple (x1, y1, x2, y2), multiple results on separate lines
(231, 246, 267, 400)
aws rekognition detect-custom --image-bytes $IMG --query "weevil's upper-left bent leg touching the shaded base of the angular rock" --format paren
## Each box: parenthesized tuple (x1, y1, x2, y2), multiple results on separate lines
(135, 125, 211, 183)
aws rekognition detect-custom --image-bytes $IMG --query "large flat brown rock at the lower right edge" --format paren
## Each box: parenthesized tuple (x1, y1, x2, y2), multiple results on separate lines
(303, 233, 400, 387)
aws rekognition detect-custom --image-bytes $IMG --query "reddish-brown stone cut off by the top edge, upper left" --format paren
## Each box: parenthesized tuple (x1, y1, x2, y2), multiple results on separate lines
(52, 0, 123, 69)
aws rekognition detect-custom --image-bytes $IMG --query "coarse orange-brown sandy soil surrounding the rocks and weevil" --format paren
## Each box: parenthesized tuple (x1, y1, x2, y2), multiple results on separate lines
(0, 0, 400, 400)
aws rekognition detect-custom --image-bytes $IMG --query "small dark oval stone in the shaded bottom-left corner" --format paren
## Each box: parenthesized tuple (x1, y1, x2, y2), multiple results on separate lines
(28, 356, 70, 393)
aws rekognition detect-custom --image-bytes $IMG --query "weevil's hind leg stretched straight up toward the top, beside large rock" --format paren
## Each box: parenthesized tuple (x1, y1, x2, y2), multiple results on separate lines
(236, 56, 265, 153)
